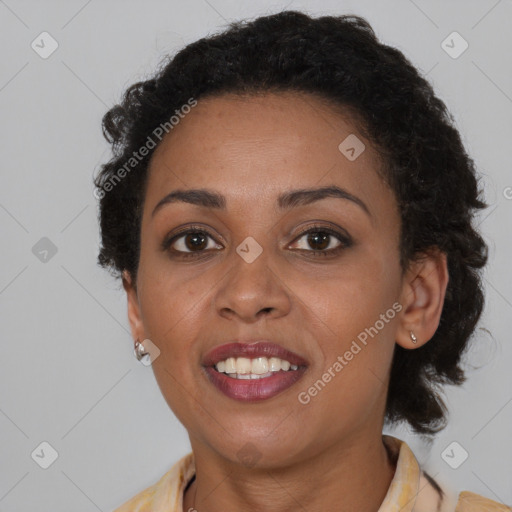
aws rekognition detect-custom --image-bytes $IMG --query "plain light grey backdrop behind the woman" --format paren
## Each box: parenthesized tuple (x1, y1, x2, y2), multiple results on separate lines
(0, 0, 512, 512)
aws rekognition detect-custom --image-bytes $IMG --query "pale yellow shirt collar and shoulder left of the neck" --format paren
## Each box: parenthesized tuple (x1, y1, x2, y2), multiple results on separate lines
(114, 452, 195, 512)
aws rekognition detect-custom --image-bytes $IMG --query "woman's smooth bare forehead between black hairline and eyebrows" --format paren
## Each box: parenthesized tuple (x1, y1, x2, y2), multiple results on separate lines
(146, 92, 389, 216)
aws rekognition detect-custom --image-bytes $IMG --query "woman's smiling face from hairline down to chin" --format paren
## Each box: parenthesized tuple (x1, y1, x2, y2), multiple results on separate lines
(126, 93, 410, 465)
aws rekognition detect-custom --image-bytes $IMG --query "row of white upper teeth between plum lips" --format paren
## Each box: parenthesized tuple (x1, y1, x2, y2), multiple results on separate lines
(215, 357, 299, 379)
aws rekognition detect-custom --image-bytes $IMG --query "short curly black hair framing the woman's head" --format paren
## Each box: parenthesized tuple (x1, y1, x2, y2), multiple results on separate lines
(94, 11, 487, 435)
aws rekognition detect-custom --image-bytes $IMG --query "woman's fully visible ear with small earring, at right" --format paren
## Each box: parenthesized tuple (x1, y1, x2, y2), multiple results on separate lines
(396, 248, 449, 349)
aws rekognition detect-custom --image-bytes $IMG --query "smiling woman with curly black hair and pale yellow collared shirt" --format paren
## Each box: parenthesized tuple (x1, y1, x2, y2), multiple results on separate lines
(95, 11, 510, 512)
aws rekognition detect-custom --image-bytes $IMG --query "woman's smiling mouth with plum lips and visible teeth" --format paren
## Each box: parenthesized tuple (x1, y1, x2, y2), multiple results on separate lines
(202, 340, 308, 401)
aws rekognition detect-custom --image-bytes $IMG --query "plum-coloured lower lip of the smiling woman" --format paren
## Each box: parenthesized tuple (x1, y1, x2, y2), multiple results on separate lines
(205, 366, 306, 402)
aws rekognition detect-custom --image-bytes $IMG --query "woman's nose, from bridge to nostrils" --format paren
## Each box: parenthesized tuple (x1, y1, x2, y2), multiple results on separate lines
(214, 246, 291, 323)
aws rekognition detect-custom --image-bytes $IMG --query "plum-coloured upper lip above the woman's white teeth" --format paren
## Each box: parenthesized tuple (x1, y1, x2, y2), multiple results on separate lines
(203, 340, 308, 366)
